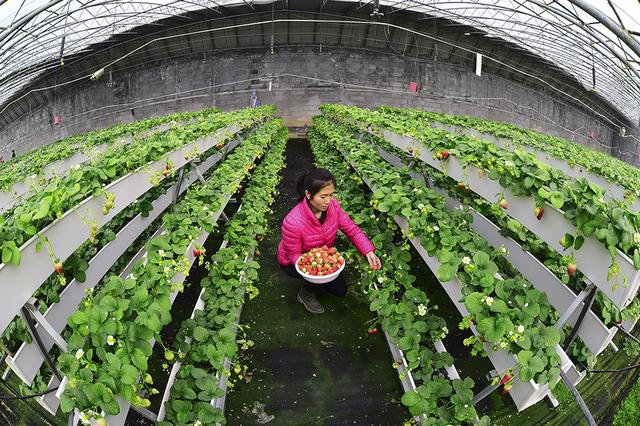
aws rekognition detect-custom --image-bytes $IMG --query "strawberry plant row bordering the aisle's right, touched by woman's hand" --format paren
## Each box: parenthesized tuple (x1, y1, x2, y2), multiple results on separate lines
(309, 121, 488, 424)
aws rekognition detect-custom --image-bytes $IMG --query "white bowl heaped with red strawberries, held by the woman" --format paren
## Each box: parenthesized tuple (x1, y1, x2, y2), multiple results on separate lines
(296, 246, 345, 284)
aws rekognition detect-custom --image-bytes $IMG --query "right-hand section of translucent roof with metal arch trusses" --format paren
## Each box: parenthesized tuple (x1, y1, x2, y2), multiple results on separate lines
(383, 0, 640, 123)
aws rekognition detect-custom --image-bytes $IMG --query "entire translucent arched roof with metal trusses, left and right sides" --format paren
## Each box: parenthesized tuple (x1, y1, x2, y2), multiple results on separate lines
(0, 0, 640, 122)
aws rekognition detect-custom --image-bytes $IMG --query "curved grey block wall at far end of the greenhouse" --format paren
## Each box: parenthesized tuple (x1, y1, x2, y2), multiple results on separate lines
(0, 48, 637, 164)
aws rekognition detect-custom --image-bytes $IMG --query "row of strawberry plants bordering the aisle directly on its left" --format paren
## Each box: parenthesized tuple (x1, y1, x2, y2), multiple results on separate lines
(160, 128, 287, 425)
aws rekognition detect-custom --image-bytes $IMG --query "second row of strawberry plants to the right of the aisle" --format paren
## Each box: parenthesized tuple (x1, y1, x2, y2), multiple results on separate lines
(314, 114, 562, 386)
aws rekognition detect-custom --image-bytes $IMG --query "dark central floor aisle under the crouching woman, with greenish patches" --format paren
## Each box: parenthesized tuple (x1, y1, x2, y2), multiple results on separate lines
(225, 140, 409, 425)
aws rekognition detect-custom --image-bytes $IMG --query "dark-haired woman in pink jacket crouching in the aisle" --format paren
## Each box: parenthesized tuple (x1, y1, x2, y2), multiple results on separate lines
(278, 169, 380, 314)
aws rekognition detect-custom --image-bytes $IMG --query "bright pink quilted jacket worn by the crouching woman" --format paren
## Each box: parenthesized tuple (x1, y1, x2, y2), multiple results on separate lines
(278, 199, 375, 266)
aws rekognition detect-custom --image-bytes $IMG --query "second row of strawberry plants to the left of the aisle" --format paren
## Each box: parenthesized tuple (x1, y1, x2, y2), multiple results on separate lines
(58, 121, 280, 415)
